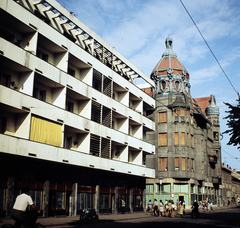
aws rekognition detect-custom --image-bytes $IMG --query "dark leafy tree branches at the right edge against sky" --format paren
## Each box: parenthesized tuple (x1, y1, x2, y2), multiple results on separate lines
(223, 97, 240, 149)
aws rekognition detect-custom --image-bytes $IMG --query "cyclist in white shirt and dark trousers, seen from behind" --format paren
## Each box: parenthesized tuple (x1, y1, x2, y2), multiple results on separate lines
(12, 188, 36, 228)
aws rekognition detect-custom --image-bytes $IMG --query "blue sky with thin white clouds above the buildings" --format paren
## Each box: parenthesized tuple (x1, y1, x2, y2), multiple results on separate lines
(57, 0, 240, 171)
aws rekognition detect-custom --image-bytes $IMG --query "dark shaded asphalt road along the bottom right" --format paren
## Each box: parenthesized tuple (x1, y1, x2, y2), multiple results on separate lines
(47, 208, 240, 228)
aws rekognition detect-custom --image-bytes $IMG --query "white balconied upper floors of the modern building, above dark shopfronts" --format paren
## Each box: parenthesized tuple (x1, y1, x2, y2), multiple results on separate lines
(0, 0, 155, 217)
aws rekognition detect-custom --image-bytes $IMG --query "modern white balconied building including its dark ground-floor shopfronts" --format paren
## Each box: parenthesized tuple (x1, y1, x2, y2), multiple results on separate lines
(0, 0, 155, 217)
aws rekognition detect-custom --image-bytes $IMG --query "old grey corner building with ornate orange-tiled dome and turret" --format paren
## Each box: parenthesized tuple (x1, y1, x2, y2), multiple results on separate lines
(144, 37, 221, 207)
